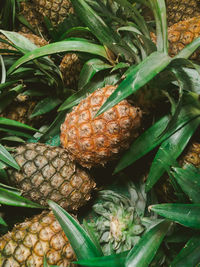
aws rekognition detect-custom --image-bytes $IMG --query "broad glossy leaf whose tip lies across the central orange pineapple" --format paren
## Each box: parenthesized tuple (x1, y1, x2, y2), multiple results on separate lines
(96, 52, 172, 117)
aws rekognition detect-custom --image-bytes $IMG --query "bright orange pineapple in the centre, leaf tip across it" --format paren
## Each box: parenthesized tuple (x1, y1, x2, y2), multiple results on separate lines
(60, 85, 142, 168)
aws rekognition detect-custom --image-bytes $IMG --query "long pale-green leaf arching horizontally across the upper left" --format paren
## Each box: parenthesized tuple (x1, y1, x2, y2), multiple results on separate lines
(7, 38, 109, 75)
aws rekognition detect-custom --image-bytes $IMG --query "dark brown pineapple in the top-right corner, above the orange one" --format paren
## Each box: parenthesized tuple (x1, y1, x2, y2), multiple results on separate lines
(166, 0, 200, 26)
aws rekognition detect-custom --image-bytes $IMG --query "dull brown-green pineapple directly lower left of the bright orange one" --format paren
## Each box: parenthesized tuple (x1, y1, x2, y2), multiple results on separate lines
(7, 143, 95, 213)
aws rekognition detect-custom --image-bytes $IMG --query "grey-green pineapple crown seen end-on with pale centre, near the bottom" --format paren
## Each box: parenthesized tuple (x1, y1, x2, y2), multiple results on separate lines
(86, 181, 146, 255)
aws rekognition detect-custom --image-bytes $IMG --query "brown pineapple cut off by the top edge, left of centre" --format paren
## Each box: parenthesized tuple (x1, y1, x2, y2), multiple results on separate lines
(33, 0, 74, 26)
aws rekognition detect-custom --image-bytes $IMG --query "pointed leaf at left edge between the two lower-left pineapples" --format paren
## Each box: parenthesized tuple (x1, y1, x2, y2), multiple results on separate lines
(0, 187, 45, 209)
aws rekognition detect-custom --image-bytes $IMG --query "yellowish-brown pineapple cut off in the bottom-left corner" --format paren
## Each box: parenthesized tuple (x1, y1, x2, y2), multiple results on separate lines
(0, 211, 76, 267)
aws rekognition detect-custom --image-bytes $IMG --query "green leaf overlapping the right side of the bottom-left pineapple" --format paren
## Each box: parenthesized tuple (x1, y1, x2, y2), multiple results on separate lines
(48, 200, 102, 260)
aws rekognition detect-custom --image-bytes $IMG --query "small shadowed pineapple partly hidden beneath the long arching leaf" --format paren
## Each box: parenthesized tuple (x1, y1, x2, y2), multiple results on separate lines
(59, 53, 82, 88)
